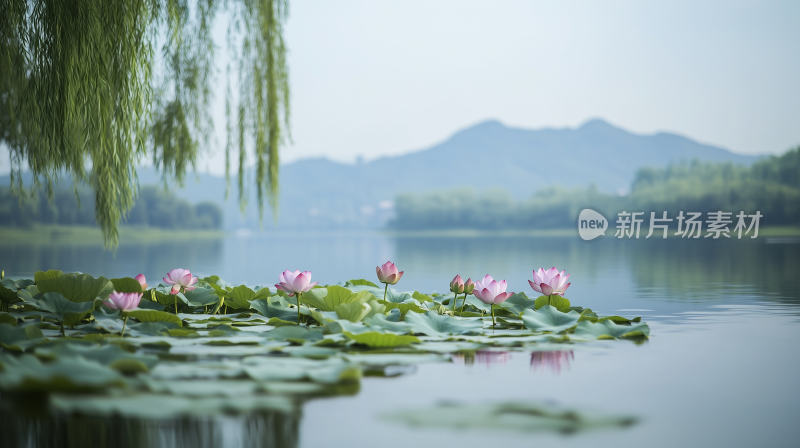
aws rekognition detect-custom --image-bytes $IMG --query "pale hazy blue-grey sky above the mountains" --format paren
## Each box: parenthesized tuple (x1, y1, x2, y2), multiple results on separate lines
(0, 0, 800, 176)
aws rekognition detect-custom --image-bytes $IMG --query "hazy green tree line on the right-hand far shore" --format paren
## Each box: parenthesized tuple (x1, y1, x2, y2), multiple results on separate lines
(389, 147, 800, 230)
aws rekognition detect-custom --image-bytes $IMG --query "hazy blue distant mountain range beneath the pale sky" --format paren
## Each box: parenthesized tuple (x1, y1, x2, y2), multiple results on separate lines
(0, 120, 758, 229)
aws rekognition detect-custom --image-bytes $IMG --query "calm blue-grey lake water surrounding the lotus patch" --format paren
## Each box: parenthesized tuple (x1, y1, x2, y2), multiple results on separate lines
(0, 233, 800, 448)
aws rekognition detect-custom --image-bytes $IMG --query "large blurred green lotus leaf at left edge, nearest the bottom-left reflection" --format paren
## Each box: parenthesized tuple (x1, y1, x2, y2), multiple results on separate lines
(0, 354, 125, 393)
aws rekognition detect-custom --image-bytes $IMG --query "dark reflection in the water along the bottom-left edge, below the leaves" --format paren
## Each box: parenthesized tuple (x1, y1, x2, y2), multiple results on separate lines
(0, 397, 302, 448)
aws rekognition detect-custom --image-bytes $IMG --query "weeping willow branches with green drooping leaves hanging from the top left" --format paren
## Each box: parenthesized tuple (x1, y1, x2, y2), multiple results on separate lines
(0, 0, 289, 247)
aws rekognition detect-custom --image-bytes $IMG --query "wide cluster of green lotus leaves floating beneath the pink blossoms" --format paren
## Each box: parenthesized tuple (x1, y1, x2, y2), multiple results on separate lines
(0, 271, 649, 430)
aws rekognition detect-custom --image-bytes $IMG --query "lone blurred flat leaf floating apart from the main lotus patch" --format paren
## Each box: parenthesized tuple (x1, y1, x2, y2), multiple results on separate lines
(382, 400, 636, 434)
